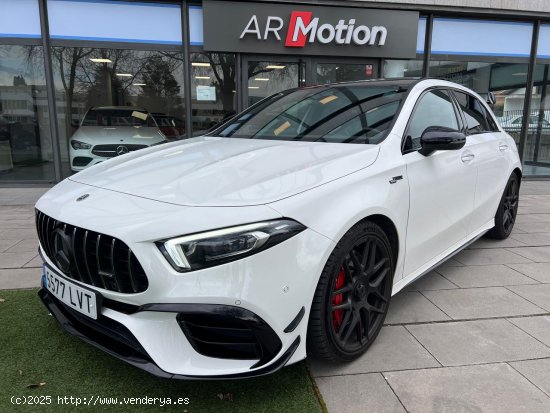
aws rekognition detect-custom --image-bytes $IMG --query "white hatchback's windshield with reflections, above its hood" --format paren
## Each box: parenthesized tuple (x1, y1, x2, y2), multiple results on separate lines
(210, 84, 406, 144)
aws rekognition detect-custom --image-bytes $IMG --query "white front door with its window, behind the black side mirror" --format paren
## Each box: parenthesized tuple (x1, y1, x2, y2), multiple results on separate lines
(403, 89, 476, 276)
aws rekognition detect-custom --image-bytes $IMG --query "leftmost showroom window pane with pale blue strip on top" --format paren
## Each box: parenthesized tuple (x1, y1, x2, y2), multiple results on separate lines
(0, 0, 55, 182)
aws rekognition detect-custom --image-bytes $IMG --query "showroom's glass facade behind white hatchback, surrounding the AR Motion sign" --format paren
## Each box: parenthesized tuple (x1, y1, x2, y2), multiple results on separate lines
(0, 0, 550, 184)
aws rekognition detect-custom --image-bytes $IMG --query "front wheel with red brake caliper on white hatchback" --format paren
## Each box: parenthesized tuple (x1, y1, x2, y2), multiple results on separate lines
(307, 221, 395, 361)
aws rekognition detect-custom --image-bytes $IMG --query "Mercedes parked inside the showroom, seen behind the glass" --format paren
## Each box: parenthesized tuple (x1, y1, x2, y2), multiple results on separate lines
(69, 106, 166, 172)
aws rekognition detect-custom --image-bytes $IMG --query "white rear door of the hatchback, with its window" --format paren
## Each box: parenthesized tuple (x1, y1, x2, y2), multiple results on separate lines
(452, 90, 513, 232)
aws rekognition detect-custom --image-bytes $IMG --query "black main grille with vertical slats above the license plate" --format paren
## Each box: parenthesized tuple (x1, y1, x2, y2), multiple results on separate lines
(36, 210, 149, 293)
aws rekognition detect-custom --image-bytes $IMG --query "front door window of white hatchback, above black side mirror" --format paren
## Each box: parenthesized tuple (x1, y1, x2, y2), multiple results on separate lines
(405, 90, 458, 150)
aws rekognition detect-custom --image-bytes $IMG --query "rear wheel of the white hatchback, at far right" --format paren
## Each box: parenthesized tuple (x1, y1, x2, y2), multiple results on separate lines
(487, 173, 520, 239)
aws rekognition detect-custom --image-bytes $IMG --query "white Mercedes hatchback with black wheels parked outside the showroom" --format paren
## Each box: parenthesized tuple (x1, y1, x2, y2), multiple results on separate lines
(36, 79, 521, 378)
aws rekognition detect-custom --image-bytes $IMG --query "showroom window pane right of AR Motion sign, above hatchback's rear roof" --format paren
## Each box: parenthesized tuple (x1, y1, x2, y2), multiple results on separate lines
(429, 17, 533, 157)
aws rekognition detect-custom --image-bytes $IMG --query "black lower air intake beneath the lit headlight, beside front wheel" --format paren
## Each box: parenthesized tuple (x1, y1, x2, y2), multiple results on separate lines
(176, 304, 281, 365)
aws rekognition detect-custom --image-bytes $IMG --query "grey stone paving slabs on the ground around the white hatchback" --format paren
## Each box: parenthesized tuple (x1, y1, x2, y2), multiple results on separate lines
(0, 181, 550, 413)
